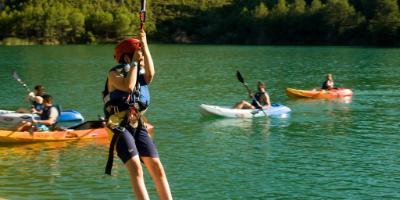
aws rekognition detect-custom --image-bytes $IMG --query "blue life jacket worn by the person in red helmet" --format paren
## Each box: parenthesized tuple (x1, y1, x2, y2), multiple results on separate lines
(103, 64, 150, 118)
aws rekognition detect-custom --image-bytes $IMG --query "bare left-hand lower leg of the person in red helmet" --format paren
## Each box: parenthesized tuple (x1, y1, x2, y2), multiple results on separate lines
(125, 156, 150, 200)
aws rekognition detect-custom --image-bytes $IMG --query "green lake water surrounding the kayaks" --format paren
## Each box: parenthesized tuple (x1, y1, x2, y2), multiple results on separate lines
(0, 45, 400, 199)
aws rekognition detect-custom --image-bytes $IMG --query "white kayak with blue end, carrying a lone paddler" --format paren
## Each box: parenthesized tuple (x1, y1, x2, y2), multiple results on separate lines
(200, 104, 292, 118)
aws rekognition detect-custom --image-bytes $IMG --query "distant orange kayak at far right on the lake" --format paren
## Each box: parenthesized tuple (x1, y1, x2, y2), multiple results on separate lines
(286, 88, 353, 99)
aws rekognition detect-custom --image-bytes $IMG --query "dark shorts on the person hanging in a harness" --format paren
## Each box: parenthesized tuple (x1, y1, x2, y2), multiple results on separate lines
(113, 126, 158, 163)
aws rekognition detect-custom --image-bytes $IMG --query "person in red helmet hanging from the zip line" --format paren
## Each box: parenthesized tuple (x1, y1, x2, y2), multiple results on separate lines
(103, 30, 172, 199)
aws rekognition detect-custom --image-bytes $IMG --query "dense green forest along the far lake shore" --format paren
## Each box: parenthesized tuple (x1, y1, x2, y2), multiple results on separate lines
(0, 0, 400, 46)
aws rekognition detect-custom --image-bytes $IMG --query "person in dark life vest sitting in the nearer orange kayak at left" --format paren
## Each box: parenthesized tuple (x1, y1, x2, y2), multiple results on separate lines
(15, 94, 60, 131)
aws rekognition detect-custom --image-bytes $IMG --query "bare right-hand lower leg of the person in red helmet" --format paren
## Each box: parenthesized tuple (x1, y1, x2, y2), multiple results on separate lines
(141, 157, 172, 200)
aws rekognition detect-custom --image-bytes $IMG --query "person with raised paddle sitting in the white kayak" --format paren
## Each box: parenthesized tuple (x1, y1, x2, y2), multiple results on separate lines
(233, 81, 271, 109)
